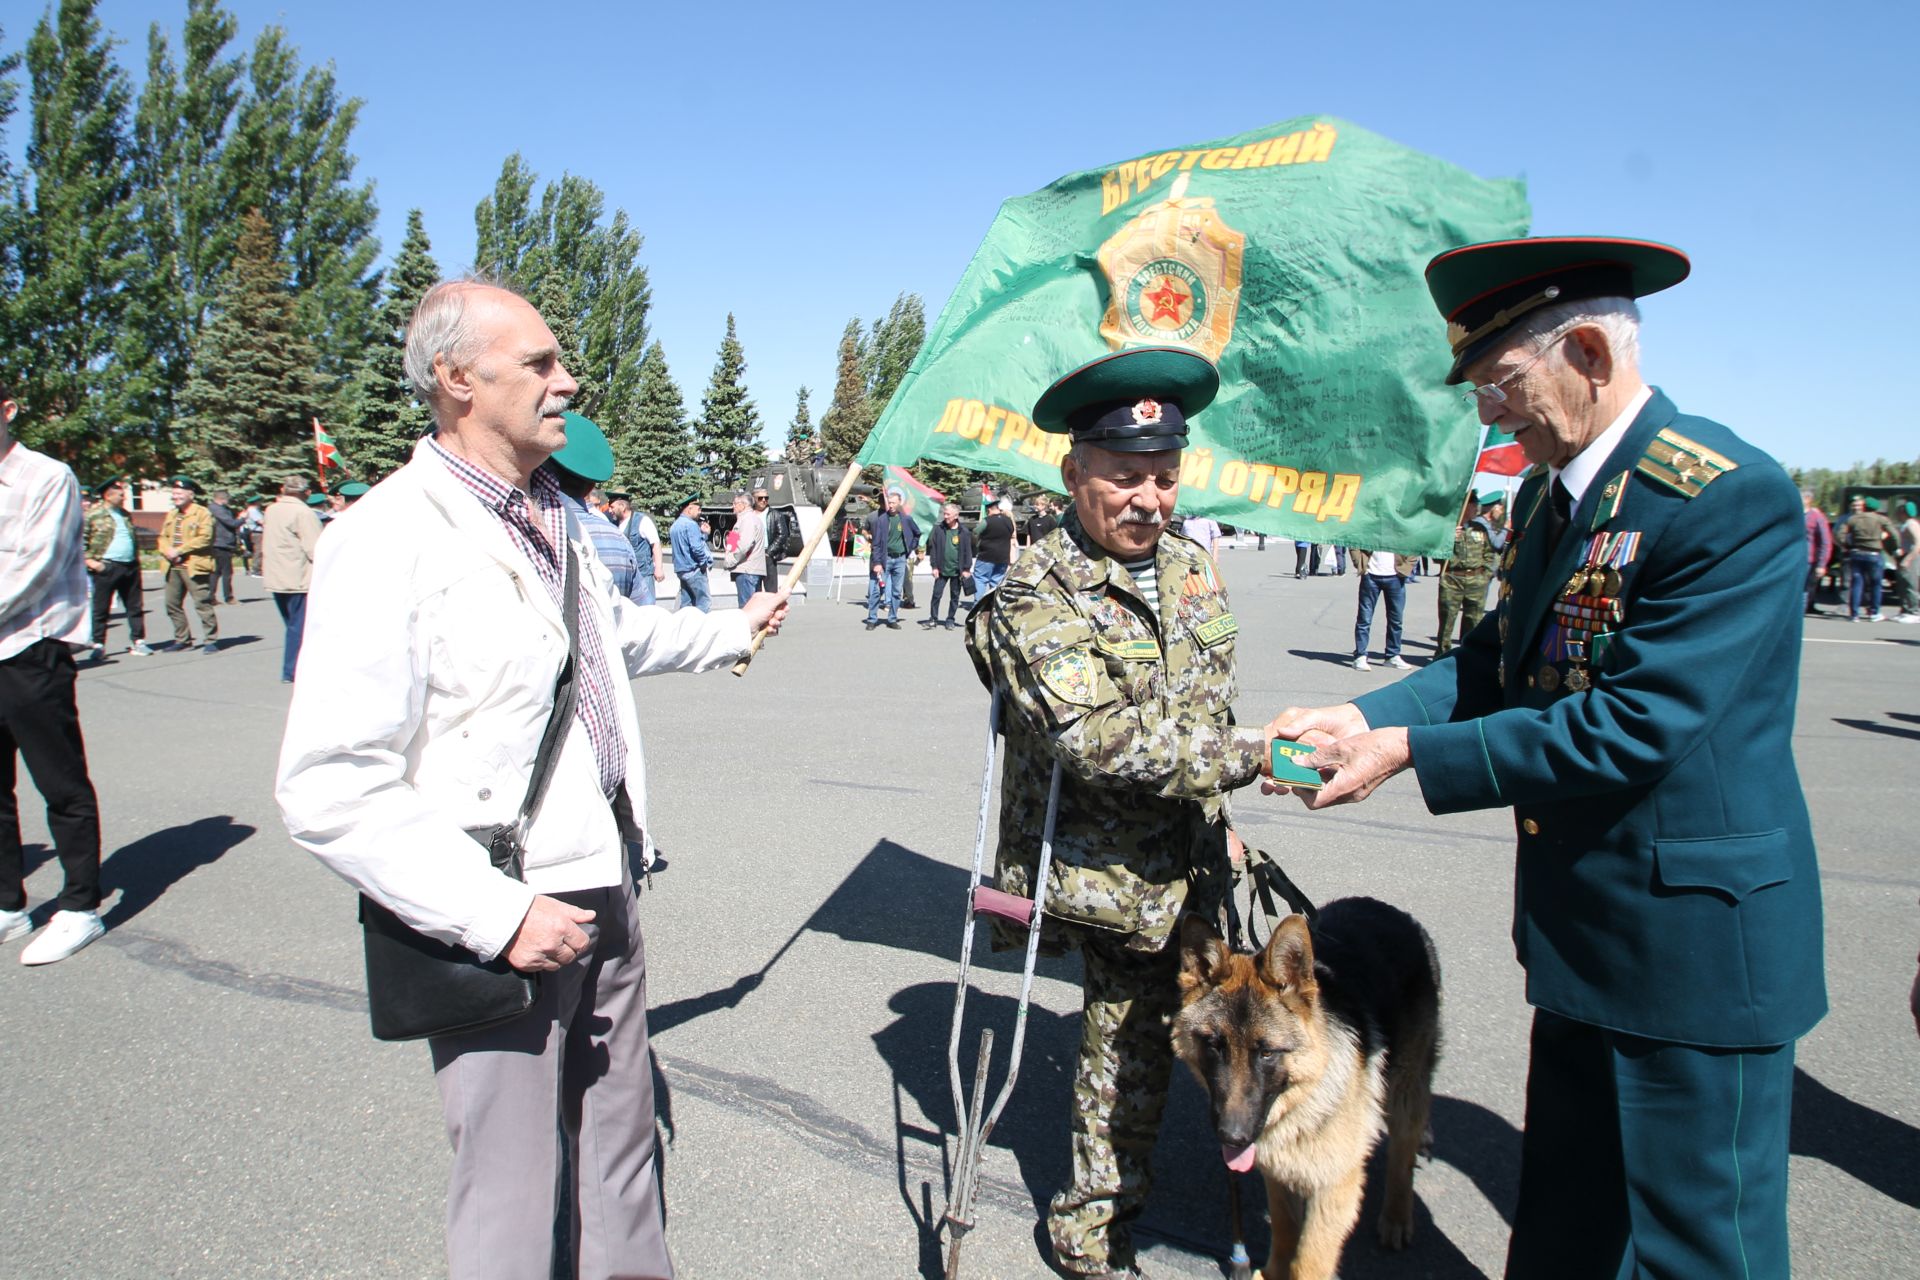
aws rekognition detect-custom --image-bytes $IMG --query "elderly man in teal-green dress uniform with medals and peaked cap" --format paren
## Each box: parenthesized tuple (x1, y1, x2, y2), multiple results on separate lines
(1273, 238, 1826, 1280)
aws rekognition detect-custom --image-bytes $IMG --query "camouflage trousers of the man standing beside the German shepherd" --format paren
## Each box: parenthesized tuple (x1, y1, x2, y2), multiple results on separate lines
(1046, 931, 1179, 1274)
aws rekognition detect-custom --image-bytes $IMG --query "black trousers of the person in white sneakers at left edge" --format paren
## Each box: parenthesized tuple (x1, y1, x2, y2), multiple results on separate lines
(0, 639, 100, 912)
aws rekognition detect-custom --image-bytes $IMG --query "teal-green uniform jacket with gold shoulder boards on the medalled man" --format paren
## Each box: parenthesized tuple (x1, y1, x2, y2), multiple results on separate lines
(1357, 391, 1826, 1046)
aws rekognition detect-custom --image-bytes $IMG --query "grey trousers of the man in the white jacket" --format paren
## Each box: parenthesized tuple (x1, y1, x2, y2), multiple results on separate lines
(428, 881, 674, 1280)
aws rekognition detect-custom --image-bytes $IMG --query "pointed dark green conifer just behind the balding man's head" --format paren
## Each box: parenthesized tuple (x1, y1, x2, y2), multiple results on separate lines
(340, 209, 440, 480)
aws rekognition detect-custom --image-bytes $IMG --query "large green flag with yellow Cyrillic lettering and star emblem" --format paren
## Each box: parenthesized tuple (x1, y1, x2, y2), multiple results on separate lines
(860, 117, 1528, 555)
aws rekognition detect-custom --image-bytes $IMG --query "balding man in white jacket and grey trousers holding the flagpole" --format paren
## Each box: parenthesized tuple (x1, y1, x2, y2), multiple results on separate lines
(278, 280, 785, 1280)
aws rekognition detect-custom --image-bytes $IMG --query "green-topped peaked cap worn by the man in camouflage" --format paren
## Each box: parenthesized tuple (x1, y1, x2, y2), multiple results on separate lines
(1033, 347, 1219, 453)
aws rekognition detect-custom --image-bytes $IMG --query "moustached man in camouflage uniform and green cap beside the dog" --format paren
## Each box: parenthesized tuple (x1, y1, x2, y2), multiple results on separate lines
(968, 347, 1269, 1276)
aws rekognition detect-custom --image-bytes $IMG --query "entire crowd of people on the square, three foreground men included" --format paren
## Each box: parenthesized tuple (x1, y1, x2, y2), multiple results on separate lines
(0, 238, 1873, 1280)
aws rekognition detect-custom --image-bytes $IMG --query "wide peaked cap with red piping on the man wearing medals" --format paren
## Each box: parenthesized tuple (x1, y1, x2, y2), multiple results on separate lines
(1427, 236, 1693, 384)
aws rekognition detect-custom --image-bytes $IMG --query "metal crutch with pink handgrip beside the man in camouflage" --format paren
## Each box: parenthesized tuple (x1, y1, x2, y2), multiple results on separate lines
(941, 689, 1060, 1280)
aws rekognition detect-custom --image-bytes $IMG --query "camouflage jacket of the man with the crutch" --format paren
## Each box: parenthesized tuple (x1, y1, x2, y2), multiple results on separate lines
(966, 510, 1267, 952)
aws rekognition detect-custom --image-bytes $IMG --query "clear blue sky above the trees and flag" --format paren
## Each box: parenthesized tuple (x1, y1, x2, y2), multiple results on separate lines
(18, 0, 1920, 466)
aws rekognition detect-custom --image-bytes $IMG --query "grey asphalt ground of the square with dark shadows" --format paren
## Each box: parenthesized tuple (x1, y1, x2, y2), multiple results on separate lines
(0, 543, 1920, 1280)
